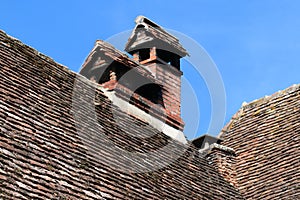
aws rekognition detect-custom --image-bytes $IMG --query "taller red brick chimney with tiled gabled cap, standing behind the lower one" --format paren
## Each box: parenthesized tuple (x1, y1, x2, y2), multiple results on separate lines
(125, 16, 188, 130)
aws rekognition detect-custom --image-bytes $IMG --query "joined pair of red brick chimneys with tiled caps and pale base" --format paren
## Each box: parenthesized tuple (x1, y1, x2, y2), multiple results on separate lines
(80, 16, 188, 141)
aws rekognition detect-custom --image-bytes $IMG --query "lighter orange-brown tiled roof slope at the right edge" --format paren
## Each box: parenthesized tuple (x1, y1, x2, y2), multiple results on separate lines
(220, 85, 300, 199)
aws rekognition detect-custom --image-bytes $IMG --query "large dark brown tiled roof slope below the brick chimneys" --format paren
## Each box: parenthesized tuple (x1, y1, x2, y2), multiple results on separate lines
(0, 31, 241, 199)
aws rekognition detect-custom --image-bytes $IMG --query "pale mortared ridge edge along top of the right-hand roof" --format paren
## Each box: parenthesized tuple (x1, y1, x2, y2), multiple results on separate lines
(217, 84, 300, 138)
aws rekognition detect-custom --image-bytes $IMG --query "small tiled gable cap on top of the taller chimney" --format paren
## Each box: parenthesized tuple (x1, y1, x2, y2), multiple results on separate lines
(125, 16, 188, 57)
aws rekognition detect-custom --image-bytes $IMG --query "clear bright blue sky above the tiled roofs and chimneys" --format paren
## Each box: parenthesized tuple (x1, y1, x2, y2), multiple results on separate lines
(0, 0, 300, 139)
